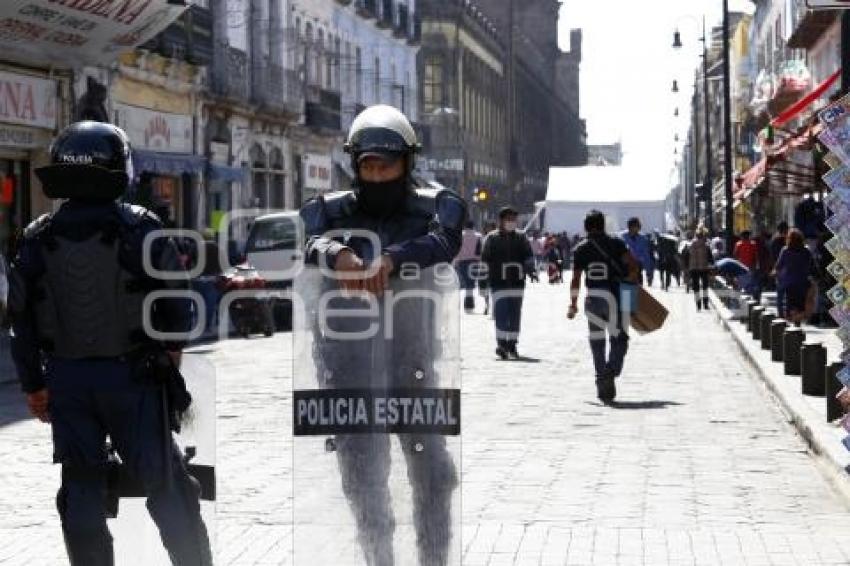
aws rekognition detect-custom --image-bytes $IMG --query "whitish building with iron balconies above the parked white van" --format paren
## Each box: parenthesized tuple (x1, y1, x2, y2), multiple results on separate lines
(202, 0, 304, 241)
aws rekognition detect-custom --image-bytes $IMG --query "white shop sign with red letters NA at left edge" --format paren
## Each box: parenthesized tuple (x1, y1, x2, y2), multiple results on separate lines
(0, 71, 56, 130)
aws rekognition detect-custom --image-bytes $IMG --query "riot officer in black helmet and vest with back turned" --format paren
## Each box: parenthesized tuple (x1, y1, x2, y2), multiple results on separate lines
(9, 122, 212, 566)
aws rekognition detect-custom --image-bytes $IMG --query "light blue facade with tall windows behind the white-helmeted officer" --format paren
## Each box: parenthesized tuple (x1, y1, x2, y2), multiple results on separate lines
(286, 0, 419, 202)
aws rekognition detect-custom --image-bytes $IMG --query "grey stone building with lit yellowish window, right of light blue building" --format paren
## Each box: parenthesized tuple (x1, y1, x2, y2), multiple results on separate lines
(418, 0, 510, 219)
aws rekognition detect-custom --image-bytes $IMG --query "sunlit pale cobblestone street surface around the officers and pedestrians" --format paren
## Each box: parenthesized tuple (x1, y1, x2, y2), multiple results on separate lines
(0, 284, 850, 566)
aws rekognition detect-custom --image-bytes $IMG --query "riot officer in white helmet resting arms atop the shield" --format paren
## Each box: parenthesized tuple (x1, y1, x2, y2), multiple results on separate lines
(301, 105, 466, 566)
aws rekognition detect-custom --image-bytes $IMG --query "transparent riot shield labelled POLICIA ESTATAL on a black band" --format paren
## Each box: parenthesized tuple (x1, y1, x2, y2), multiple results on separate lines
(293, 265, 461, 566)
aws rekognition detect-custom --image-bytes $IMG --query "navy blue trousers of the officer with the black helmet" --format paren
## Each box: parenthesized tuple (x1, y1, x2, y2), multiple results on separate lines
(47, 359, 212, 566)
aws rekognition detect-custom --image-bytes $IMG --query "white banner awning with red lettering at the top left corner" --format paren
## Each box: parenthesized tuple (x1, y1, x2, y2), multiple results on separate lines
(0, 0, 187, 68)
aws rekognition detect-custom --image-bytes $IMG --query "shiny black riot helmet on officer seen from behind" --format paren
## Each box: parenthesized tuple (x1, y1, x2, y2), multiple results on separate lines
(35, 121, 133, 201)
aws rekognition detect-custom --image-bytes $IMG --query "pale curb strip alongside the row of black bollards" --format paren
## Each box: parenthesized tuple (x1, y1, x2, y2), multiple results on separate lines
(710, 289, 850, 504)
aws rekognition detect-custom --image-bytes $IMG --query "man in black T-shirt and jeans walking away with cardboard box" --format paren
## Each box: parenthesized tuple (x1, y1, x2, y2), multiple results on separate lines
(567, 210, 640, 403)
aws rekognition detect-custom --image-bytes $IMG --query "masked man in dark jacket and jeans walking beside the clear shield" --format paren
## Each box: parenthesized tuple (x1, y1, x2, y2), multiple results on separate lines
(481, 206, 534, 360)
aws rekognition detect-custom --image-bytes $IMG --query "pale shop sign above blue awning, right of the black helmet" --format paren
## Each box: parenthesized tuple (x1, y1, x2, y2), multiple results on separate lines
(115, 104, 192, 153)
